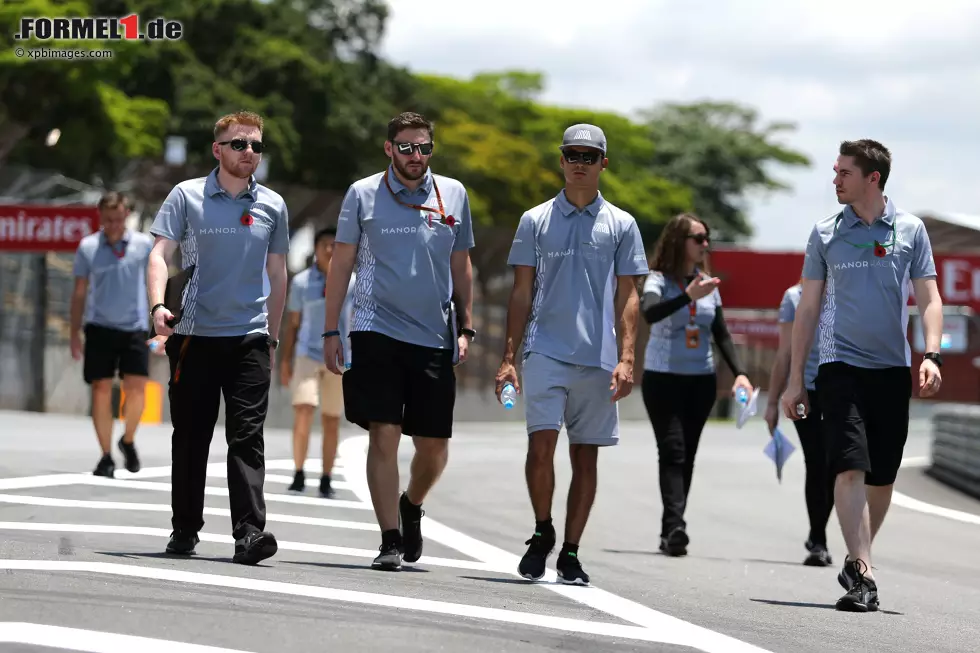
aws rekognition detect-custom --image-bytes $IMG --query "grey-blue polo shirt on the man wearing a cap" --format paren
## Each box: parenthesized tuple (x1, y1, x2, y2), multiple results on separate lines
(507, 190, 649, 371)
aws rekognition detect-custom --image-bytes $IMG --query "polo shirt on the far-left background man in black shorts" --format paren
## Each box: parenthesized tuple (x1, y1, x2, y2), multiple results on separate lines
(74, 229, 153, 331)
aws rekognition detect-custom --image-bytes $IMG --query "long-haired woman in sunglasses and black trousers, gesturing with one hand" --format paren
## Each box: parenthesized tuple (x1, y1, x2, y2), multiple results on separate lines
(640, 213, 752, 556)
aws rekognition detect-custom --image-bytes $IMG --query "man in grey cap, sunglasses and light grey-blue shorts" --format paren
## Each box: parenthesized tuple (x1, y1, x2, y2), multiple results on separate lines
(496, 124, 649, 585)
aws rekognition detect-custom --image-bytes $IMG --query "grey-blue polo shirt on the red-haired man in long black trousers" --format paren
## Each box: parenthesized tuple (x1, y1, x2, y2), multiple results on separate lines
(150, 168, 289, 337)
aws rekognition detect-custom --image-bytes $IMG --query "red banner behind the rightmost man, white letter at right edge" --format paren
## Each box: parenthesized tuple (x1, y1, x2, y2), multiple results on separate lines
(711, 249, 980, 312)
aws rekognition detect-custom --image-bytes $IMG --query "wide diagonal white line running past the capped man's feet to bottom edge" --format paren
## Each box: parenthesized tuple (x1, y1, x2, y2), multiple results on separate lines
(340, 435, 769, 653)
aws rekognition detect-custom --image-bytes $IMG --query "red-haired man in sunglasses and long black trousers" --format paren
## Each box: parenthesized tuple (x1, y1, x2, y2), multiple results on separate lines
(148, 111, 289, 565)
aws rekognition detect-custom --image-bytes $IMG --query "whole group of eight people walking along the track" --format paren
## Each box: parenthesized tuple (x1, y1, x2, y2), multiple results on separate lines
(72, 105, 942, 610)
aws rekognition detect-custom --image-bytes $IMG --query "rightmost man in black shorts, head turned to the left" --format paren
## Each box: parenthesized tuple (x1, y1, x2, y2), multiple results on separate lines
(782, 140, 943, 612)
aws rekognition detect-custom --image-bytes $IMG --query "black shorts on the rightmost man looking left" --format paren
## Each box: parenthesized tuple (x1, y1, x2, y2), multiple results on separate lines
(816, 363, 912, 486)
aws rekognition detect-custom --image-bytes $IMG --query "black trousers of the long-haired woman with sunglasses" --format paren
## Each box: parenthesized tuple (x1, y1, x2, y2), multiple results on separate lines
(642, 371, 717, 537)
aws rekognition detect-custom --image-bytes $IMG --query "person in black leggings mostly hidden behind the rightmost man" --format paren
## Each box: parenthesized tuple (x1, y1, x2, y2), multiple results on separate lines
(766, 279, 834, 567)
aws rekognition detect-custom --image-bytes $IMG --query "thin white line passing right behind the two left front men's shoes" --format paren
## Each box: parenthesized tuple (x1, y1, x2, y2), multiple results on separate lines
(0, 522, 500, 572)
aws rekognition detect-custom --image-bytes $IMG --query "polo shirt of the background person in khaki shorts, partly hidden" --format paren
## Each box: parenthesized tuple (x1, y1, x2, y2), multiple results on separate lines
(286, 259, 356, 363)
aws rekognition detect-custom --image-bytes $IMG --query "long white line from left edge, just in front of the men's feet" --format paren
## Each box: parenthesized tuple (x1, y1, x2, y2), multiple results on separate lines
(0, 560, 688, 651)
